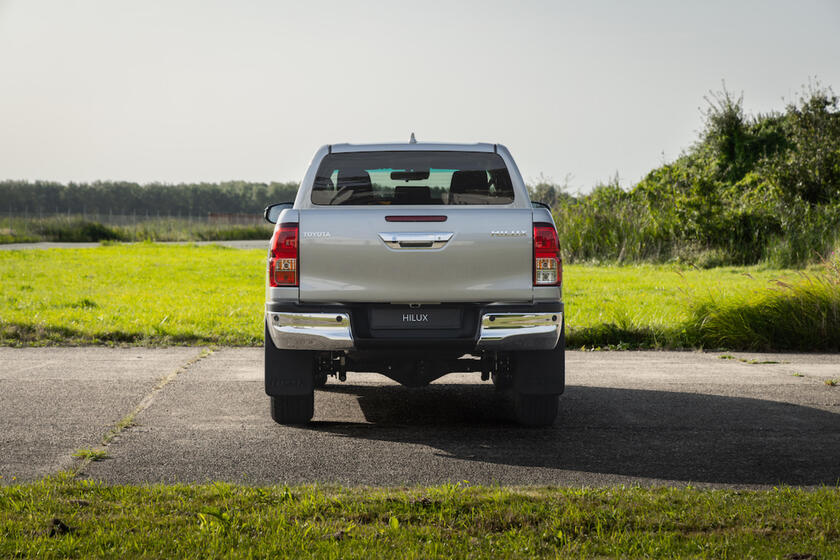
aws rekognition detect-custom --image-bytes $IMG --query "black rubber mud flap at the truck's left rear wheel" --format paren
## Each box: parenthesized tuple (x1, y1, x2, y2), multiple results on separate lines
(265, 325, 315, 397)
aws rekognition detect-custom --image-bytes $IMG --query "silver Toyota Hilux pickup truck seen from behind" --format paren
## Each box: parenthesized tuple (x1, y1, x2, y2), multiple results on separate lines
(265, 141, 565, 425)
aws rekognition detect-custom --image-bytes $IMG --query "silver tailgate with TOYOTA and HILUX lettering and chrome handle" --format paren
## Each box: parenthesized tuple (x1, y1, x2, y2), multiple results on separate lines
(298, 206, 533, 303)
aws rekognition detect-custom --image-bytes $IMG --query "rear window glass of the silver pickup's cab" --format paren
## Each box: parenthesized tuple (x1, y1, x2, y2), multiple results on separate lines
(312, 152, 513, 206)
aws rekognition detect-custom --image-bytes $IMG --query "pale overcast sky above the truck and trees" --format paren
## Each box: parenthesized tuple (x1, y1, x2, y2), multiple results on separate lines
(0, 0, 840, 191)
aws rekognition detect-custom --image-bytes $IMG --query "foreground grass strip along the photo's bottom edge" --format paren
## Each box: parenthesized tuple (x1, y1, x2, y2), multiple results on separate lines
(0, 478, 840, 559)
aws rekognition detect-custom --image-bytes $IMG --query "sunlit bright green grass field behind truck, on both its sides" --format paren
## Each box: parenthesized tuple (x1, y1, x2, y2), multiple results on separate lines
(0, 243, 840, 349)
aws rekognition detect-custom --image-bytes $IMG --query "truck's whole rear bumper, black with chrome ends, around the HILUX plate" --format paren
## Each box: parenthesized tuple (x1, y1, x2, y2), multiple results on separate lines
(265, 302, 563, 352)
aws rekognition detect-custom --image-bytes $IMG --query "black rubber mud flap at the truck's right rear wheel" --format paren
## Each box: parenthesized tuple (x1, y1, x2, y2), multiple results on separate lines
(513, 322, 566, 395)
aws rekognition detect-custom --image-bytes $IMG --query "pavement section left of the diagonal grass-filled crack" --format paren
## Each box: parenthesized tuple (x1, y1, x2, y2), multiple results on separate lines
(0, 347, 201, 484)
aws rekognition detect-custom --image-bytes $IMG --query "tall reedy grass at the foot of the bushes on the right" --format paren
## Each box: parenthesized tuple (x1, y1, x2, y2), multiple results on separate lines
(553, 184, 840, 268)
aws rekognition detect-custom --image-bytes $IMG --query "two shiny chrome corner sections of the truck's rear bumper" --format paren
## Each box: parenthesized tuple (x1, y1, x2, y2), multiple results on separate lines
(265, 311, 563, 351)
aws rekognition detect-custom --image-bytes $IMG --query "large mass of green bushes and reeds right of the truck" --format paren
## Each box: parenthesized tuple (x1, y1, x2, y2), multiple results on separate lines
(548, 81, 840, 267)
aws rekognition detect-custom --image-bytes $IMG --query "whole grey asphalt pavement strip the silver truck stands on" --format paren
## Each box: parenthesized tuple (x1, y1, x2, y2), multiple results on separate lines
(0, 348, 840, 488)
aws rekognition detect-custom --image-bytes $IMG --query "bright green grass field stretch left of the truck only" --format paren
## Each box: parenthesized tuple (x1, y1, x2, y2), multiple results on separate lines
(0, 243, 265, 345)
